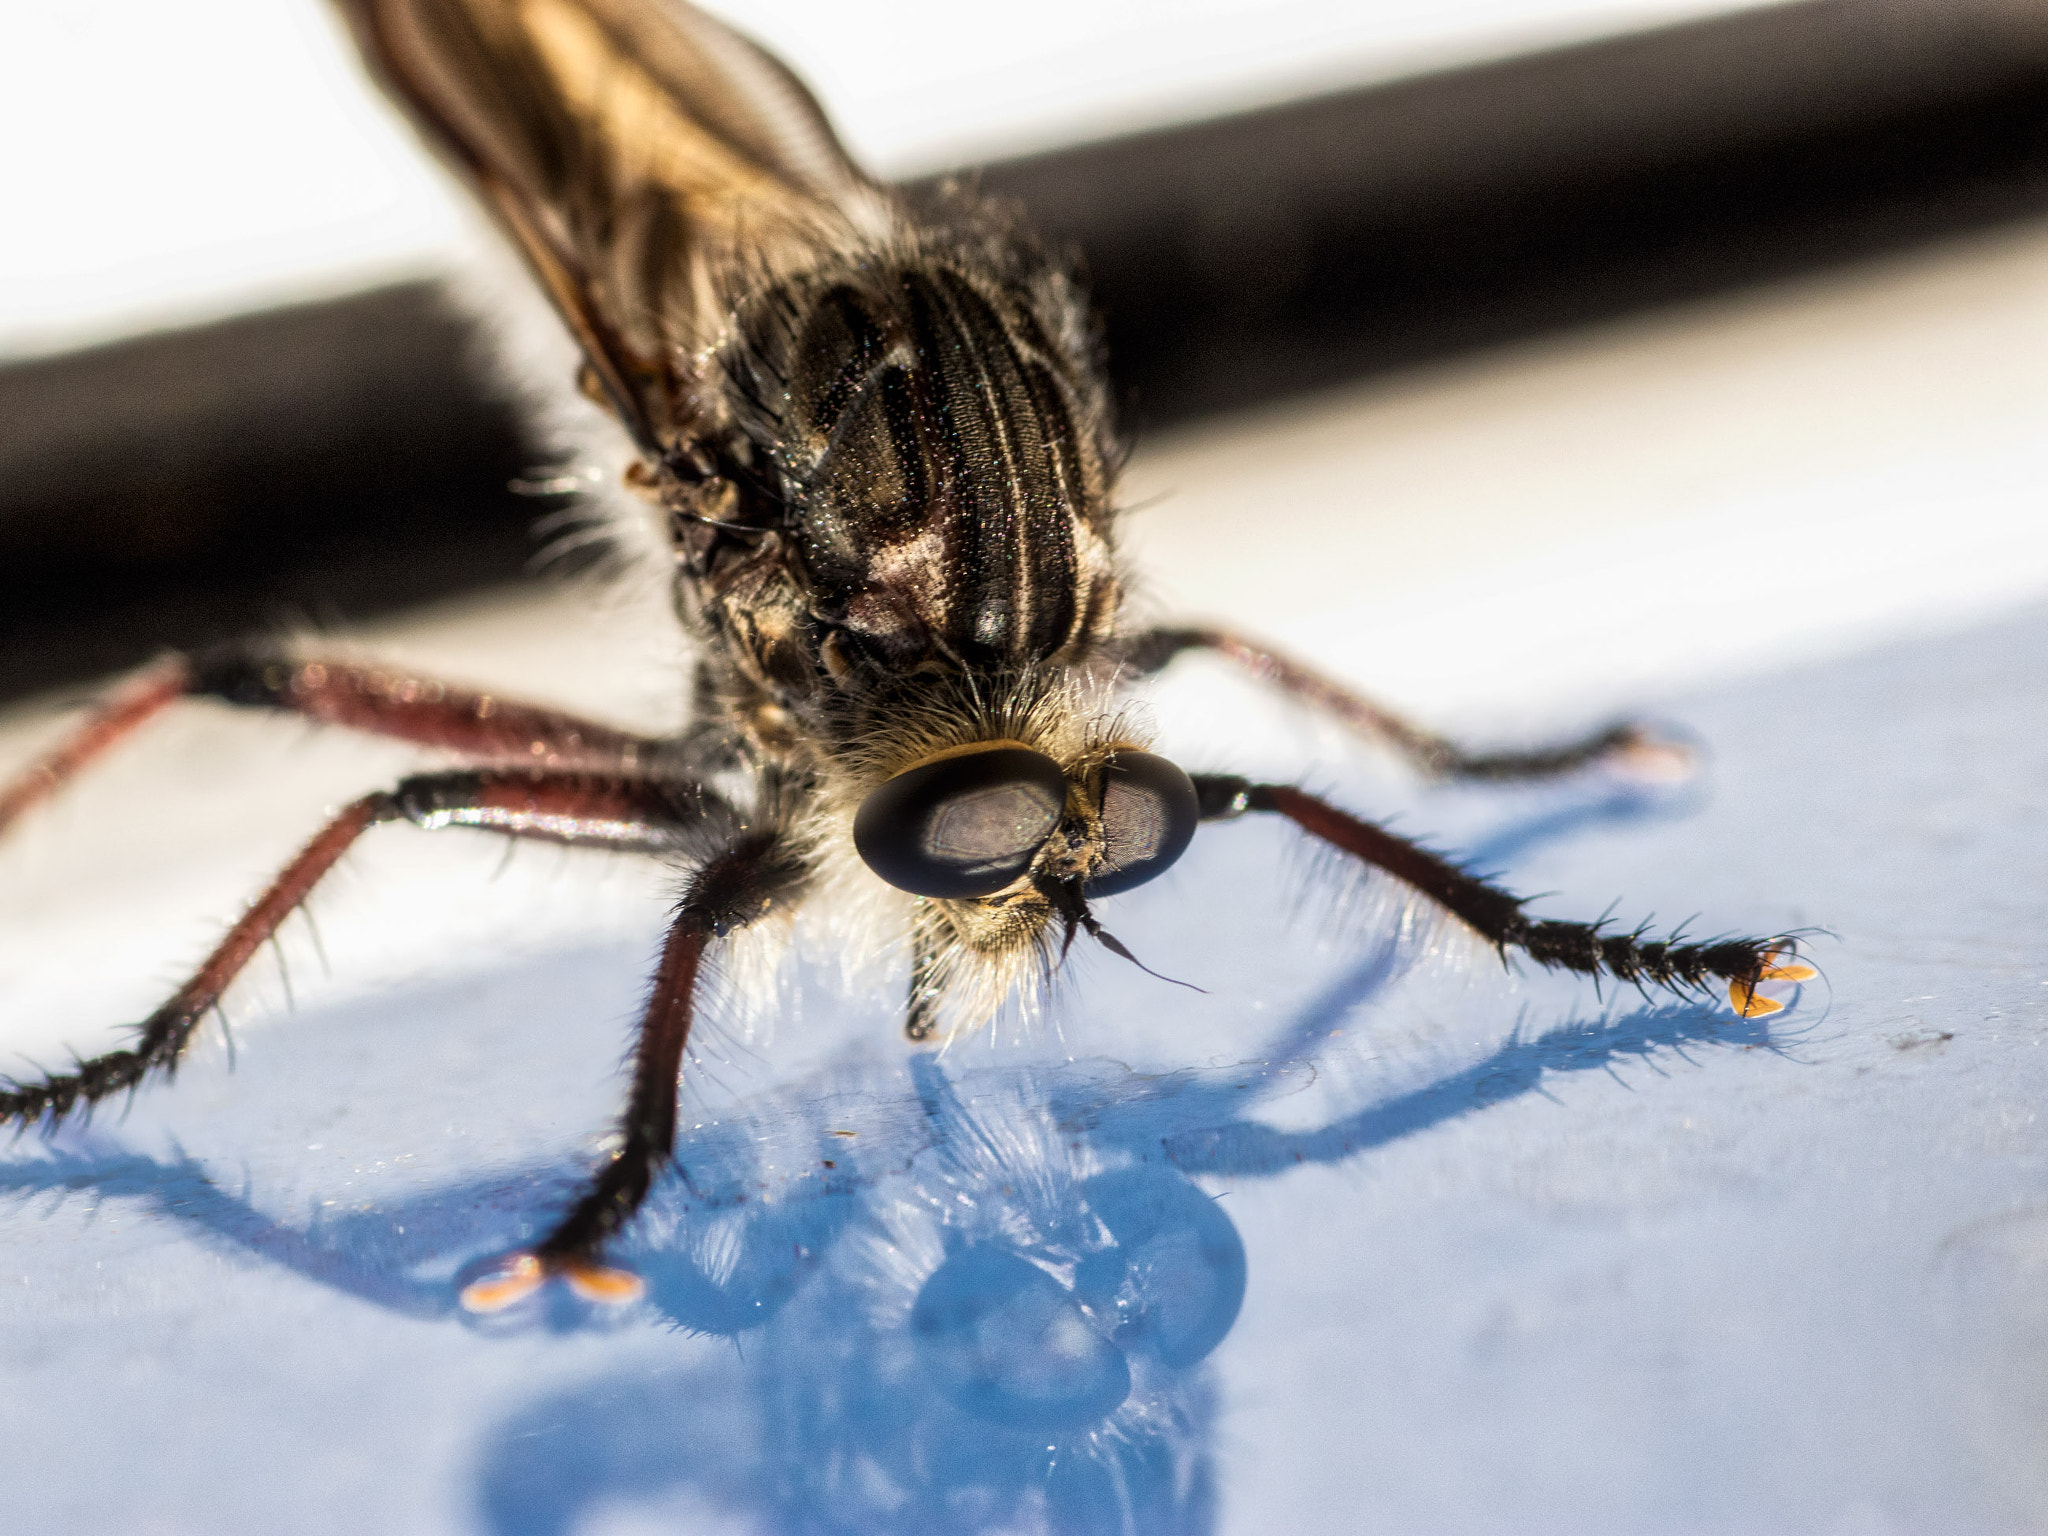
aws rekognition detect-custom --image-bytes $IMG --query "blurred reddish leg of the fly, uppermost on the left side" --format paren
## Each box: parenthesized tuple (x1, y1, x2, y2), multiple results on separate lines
(0, 643, 662, 847)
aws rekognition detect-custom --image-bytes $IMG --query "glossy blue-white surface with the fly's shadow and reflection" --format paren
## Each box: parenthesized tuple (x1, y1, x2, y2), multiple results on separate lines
(0, 593, 2048, 1532)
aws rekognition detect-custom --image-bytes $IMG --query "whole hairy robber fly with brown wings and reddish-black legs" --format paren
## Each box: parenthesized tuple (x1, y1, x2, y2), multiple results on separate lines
(0, 0, 1812, 1311)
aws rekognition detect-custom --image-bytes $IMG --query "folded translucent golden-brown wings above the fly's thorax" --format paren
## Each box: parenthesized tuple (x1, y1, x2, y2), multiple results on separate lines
(336, 0, 889, 455)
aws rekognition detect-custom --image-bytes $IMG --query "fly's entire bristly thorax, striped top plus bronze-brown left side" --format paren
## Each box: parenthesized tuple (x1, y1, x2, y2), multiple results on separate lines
(635, 202, 1122, 753)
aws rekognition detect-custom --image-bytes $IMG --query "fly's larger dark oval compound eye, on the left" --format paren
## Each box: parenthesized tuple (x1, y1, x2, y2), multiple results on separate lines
(854, 748, 1067, 899)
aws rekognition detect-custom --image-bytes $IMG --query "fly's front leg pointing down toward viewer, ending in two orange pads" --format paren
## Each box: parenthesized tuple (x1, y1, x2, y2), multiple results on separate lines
(463, 827, 809, 1313)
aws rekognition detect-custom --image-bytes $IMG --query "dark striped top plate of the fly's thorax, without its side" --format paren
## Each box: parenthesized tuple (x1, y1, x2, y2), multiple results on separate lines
(700, 238, 1120, 676)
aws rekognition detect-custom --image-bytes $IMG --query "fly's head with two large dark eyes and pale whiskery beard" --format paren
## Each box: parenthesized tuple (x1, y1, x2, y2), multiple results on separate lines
(835, 690, 1198, 1040)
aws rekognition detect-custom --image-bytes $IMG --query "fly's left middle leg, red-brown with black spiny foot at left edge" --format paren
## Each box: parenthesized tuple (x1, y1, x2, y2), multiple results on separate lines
(0, 770, 723, 1155)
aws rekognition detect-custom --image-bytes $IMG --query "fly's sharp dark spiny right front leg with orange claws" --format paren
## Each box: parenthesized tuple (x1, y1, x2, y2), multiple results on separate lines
(1194, 774, 1815, 1018)
